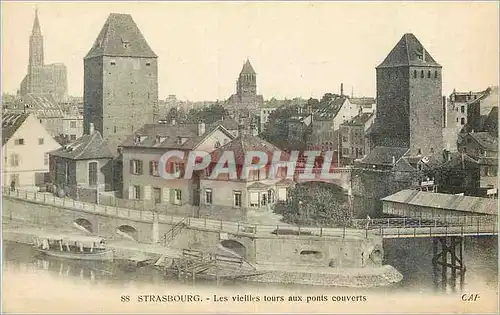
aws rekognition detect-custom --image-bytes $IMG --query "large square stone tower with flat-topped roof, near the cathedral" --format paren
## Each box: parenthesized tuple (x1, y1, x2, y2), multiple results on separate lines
(83, 13, 158, 152)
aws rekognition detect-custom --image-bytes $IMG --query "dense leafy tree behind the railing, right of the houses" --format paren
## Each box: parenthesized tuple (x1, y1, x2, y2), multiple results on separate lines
(273, 182, 352, 227)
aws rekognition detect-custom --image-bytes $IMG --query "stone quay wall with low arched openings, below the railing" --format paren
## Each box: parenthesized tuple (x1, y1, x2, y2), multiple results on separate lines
(2, 196, 384, 268)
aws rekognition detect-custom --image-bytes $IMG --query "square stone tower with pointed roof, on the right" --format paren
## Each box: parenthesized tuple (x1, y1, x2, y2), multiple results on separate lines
(370, 34, 443, 155)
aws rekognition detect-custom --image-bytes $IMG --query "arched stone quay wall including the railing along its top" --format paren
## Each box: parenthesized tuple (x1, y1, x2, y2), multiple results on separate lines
(2, 192, 383, 268)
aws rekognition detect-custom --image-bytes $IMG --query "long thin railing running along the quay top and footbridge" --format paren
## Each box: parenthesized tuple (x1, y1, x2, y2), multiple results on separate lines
(2, 189, 498, 241)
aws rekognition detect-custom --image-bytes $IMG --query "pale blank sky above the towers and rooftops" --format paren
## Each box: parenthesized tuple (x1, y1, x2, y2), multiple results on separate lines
(2, 1, 499, 101)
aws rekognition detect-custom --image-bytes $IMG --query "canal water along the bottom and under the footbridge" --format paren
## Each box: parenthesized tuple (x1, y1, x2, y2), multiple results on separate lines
(2, 237, 498, 293)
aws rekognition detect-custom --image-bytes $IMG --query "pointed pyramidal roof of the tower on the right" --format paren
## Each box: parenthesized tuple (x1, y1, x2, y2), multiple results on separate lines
(377, 33, 441, 68)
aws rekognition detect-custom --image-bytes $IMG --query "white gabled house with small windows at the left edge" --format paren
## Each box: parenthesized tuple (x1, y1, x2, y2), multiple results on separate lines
(2, 113, 60, 189)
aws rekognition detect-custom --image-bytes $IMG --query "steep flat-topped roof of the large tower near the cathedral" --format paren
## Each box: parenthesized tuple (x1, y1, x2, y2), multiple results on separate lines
(85, 13, 158, 59)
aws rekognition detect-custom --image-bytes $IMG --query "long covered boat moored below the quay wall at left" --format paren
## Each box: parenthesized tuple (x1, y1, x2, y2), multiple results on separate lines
(33, 234, 114, 261)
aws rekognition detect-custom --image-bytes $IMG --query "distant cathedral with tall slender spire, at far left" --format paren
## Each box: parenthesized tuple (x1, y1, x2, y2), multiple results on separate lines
(19, 10, 68, 101)
